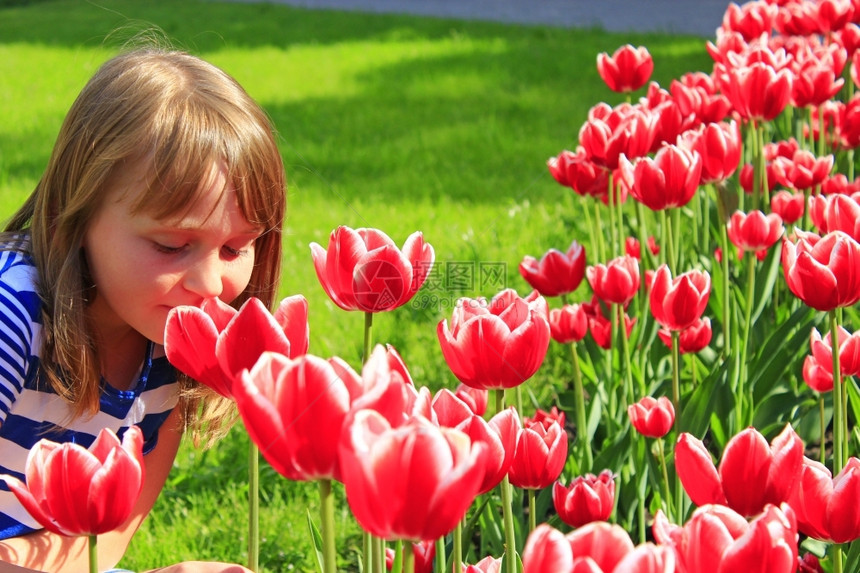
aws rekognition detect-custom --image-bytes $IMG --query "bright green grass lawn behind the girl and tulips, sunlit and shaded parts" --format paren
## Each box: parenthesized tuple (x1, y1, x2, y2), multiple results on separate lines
(0, 0, 711, 571)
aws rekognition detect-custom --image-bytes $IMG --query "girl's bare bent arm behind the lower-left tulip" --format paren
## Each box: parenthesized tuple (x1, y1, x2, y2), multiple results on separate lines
(0, 407, 182, 573)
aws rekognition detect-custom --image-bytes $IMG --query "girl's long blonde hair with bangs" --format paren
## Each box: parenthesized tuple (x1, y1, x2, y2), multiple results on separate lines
(6, 48, 286, 442)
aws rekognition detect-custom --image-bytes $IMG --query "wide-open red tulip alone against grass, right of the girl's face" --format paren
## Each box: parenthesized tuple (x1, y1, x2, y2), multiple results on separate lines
(311, 226, 435, 312)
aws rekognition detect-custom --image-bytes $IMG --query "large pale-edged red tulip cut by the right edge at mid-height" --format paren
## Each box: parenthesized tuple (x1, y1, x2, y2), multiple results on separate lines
(782, 231, 860, 311)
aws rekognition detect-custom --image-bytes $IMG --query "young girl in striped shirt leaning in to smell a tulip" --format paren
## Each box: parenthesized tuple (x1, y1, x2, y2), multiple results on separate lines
(0, 49, 286, 573)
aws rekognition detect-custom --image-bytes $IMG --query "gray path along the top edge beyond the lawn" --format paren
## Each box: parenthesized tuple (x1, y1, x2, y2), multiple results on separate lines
(247, 0, 740, 38)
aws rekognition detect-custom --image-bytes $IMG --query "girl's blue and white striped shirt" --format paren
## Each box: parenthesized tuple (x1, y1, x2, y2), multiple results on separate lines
(0, 250, 179, 539)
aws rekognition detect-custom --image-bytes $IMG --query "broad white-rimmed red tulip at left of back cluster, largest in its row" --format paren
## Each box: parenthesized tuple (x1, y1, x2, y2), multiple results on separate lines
(619, 144, 702, 211)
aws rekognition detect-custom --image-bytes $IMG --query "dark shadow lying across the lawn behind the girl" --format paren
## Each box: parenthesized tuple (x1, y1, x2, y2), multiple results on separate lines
(0, 1, 711, 206)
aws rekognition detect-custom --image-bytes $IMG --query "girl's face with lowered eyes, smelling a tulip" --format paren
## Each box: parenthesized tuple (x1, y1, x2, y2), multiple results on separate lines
(83, 159, 261, 344)
